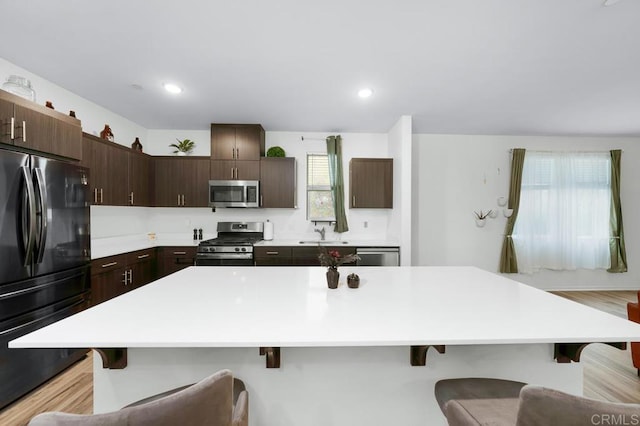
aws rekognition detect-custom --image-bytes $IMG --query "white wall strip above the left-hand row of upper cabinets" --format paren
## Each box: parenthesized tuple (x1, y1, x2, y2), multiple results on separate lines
(0, 58, 147, 146)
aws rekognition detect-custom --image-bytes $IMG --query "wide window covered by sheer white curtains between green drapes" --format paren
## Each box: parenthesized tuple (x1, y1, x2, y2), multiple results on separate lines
(513, 151, 611, 272)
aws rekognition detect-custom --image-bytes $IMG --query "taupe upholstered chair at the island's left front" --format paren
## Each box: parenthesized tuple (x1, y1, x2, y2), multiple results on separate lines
(29, 370, 249, 426)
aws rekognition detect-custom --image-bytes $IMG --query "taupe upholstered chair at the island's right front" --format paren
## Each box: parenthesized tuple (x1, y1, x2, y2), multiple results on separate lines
(435, 378, 640, 426)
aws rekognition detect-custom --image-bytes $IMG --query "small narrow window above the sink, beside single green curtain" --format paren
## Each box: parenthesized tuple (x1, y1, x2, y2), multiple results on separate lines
(307, 154, 336, 221)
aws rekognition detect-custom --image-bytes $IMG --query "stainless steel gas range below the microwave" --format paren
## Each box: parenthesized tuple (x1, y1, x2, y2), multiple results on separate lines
(196, 222, 264, 266)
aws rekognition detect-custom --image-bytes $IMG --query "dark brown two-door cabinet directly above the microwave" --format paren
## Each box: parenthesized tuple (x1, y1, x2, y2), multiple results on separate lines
(211, 123, 264, 160)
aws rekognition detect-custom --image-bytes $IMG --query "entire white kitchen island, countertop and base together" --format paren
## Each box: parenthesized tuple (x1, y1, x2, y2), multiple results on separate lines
(10, 267, 640, 426)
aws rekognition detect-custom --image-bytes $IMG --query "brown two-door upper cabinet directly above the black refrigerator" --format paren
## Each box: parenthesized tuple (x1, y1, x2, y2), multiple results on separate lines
(0, 90, 82, 160)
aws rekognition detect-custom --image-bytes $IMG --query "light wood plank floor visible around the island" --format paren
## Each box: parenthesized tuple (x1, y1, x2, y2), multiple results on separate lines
(0, 291, 640, 426)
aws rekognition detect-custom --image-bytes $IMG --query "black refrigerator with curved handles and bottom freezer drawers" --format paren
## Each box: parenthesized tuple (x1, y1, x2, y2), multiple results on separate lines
(0, 148, 91, 408)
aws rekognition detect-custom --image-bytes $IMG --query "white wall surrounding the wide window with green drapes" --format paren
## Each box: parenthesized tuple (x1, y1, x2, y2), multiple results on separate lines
(412, 134, 640, 290)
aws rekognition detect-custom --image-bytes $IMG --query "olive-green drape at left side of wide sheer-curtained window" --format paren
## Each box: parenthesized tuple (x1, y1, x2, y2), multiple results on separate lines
(500, 148, 525, 274)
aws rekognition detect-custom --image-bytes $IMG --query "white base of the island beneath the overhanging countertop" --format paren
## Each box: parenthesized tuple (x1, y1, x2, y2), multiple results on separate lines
(94, 344, 582, 426)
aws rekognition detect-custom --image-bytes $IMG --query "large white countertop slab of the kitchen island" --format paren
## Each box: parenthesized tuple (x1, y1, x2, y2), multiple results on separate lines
(9, 266, 640, 348)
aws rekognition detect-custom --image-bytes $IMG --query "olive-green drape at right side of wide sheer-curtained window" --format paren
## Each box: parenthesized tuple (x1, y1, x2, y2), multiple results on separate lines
(607, 149, 627, 272)
